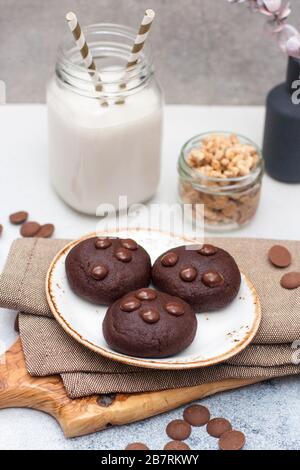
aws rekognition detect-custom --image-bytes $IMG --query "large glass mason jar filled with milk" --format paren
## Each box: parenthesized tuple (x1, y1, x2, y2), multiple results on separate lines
(47, 24, 163, 215)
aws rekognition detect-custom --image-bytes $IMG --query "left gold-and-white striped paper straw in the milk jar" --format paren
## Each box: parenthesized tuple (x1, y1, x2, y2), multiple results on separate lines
(66, 11, 107, 100)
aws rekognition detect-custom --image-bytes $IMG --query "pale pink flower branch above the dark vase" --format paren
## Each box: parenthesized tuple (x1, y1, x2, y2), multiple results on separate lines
(228, 0, 300, 59)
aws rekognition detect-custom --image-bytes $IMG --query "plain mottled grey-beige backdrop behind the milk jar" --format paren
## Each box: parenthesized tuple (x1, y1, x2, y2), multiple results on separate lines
(0, 0, 300, 104)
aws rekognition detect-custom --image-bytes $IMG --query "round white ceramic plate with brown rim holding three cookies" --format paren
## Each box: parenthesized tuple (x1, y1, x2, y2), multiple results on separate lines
(46, 229, 261, 369)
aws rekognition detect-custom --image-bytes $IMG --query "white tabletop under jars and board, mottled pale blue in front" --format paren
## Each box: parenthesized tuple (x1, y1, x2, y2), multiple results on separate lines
(0, 105, 300, 449)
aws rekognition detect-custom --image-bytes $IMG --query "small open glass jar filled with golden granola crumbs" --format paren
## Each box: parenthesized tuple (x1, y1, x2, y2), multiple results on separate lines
(178, 132, 264, 231)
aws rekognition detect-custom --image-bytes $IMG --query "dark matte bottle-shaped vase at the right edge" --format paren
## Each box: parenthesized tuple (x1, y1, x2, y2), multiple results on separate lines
(263, 58, 300, 183)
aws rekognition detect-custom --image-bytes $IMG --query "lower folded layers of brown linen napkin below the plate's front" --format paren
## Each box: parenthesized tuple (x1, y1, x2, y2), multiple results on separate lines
(19, 314, 300, 398)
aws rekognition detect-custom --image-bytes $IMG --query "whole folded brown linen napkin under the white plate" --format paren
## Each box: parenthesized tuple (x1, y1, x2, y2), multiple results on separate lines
(0, 239, 300, 398)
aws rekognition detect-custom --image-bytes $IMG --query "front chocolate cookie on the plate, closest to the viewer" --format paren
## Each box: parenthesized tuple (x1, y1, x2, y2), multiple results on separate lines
(102, 289, 197, 358)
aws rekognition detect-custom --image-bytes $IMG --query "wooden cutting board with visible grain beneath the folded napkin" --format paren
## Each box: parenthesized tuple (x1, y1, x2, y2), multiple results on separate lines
(0, 339, 263, 437)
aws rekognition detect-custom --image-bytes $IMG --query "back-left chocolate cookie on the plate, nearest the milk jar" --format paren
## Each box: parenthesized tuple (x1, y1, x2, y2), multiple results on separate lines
(66, 237, 151, 305)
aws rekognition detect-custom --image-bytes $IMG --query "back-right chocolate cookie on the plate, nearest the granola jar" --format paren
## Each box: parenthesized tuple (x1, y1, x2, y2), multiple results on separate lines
(152, 245, 241, 312)
